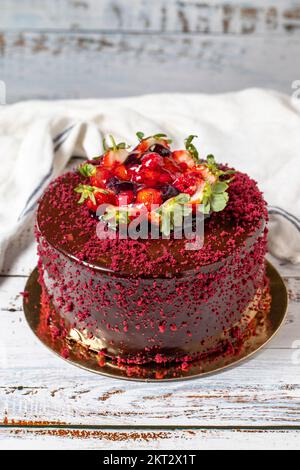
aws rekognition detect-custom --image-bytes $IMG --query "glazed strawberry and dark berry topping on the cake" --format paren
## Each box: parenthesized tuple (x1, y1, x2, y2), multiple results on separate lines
(75, 132, 234, 232)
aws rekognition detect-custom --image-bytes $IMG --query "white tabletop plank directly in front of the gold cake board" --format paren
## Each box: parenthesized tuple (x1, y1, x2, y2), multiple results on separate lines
(0, 350, 300, 427)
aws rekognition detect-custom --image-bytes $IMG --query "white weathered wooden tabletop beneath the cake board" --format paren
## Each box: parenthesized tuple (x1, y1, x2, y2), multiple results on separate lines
(0, 218, 300, 449)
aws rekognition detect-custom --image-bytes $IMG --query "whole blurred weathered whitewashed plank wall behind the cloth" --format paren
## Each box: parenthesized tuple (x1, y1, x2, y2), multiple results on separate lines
(0, 0, 300, 102)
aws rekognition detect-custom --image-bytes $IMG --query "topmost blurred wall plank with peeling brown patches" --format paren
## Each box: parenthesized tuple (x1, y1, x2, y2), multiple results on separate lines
(0, 0, 300, 34)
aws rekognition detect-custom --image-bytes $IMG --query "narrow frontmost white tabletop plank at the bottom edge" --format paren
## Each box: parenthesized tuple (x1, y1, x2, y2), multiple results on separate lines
(0, 429, 300, 452)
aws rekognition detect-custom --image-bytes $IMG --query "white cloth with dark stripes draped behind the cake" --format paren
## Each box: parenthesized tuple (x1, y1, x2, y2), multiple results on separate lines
(0, 89, 300, 268)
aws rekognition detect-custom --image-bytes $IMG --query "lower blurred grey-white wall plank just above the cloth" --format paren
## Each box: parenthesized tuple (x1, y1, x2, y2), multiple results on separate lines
(0, 32, 299, 102)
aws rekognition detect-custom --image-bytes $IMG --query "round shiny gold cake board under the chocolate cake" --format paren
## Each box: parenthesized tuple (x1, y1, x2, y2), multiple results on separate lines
(23, 261, 288, 382)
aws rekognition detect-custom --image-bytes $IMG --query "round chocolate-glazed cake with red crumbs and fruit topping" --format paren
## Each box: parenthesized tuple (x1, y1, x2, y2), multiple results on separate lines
(36, 135, 268, 364)
